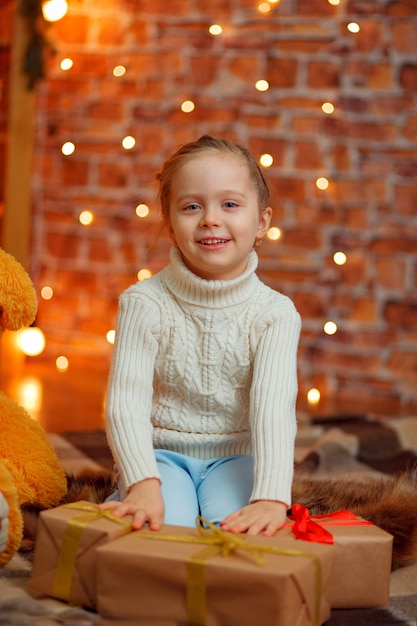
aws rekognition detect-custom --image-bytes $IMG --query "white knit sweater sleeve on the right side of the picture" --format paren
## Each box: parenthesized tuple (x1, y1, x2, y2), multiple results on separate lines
(250, 300, 301, 506)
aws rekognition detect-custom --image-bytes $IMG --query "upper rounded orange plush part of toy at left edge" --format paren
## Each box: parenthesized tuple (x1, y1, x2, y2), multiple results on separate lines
(0, 248, 38, 332)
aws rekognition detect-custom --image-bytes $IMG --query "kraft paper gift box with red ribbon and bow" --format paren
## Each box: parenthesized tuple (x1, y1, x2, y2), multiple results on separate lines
(288, 505, 393, 609)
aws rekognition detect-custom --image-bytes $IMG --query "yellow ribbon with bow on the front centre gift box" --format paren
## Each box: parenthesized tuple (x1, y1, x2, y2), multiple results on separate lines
(134, 517, 323, 626)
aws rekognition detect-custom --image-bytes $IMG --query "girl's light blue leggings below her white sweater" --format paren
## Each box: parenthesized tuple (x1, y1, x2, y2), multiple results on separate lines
(108, 450, 253, 526)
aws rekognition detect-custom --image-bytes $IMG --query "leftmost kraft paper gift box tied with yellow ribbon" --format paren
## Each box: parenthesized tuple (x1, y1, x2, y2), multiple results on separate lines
(29, 501, 131, 608)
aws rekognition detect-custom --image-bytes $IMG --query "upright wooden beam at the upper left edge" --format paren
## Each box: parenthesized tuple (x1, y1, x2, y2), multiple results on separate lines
(1, 2, 35, 269)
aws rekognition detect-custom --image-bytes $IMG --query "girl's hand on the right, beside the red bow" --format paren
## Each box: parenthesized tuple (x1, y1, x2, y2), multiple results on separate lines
(220, 500, 287, 537)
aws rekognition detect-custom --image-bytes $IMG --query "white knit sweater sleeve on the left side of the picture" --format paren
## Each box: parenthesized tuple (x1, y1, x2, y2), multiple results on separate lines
(106, 290, 159, 499)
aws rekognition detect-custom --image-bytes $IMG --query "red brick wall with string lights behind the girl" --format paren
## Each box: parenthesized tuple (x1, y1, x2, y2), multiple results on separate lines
(27, 0, 417, 411)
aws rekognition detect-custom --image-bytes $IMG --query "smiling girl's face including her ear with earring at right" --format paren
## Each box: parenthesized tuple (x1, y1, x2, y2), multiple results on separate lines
(170, 151, 272, 280)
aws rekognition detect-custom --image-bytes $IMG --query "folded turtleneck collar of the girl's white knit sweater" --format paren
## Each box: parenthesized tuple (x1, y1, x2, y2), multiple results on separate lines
(161, 247, 259, 308)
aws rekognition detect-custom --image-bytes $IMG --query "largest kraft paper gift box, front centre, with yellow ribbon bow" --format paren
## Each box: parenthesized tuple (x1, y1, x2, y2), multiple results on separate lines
(96, 525, 334, 626)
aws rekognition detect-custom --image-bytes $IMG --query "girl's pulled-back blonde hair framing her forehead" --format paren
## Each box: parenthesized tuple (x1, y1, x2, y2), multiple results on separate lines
(156, 135, 270, 224)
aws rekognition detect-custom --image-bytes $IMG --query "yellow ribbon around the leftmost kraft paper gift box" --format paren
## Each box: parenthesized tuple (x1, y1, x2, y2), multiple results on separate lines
(52, 502, 131, 601)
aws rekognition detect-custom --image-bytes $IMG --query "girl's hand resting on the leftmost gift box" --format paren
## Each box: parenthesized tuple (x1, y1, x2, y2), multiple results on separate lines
(100, 478, 164, 530)
